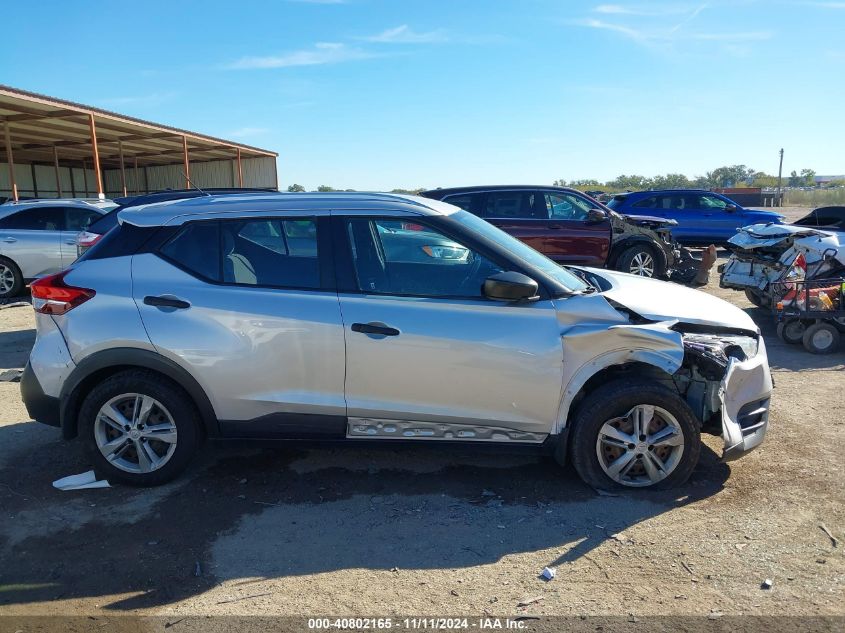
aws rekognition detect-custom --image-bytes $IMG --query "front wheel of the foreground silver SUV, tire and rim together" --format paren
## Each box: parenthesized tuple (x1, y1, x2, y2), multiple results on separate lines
(571, 380, 701, 489)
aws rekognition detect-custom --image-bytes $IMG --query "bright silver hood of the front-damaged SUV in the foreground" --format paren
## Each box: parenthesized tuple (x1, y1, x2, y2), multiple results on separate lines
(589, 268, 759, 332)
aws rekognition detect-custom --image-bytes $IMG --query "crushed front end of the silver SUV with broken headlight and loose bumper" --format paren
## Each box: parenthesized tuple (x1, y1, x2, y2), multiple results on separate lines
(672, 324, 772, 461)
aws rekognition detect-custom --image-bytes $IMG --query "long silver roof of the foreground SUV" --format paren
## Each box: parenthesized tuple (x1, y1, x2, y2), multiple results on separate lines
(118, 192, 460, 226)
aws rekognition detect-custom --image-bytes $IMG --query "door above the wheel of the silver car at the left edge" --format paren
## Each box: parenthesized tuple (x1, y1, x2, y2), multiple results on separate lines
(0, 206, 65, 279)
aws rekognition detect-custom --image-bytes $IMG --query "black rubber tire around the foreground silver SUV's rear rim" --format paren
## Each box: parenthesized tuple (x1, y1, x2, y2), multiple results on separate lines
(79, 369, 202, 486)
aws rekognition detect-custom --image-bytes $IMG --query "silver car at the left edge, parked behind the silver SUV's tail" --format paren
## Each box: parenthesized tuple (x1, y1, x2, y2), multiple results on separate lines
(0, 199, 108, 299)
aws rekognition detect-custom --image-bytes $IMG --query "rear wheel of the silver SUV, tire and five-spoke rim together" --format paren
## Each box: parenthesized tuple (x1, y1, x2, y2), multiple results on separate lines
(79, 370, 200, 486)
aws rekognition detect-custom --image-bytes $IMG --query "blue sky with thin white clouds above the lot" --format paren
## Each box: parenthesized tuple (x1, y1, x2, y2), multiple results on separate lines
(0, 0, 845, 189)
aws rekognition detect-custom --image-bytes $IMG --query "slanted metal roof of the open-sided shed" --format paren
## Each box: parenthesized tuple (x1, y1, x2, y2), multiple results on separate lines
(0, 84, 278, 168)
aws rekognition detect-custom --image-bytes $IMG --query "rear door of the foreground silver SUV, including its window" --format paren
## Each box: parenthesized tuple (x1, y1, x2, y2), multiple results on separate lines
(132, 214, 346, 437)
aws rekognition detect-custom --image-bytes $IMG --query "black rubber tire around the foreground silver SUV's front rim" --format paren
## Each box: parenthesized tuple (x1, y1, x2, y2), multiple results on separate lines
(570, 380, 701, 490)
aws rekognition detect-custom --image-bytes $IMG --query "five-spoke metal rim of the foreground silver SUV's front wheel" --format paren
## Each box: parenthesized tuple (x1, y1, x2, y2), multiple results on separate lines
(596, 404, 684, 487)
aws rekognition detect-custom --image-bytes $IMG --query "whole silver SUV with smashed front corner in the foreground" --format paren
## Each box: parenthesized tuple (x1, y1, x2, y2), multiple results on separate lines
(21, 193, 772, 488)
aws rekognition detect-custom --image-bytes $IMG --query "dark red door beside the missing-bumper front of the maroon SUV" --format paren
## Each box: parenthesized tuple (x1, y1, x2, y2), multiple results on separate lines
(537, 191, 612, 267)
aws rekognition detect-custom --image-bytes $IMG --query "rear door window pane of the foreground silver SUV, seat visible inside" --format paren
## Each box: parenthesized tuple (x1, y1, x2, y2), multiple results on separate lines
(221, 218, 320, 290)
